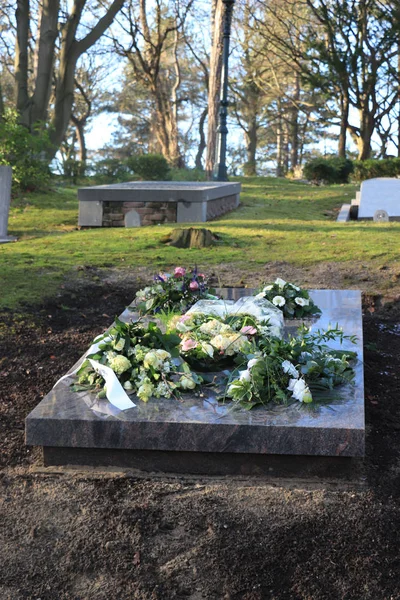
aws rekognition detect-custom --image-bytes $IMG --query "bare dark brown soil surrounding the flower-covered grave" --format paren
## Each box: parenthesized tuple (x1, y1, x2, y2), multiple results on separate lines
(0, 264, 400, 600)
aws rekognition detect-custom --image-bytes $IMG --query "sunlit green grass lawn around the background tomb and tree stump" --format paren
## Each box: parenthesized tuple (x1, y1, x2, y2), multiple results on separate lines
(0, 177, 400, 308)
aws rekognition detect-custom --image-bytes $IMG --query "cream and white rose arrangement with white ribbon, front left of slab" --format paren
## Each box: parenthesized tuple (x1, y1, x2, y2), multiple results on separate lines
(73, 319, 201, 402)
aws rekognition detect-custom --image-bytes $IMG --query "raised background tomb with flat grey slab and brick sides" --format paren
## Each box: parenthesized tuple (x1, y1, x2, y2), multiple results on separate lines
(78, 181, 241, 227)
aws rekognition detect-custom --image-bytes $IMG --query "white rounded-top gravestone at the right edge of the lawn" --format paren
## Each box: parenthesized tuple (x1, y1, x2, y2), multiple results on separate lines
(358, 177, 400, 220)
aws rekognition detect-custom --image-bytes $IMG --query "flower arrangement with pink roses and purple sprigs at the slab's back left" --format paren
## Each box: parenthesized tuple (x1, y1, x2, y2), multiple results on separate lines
(136, 267, 216, 314)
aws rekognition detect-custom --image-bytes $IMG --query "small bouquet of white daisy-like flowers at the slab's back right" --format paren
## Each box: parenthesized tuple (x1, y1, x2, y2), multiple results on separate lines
(256, 277, 321, 319)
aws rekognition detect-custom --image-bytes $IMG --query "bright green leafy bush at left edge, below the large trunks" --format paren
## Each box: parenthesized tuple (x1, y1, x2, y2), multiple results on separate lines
(0, 110, 51, 192)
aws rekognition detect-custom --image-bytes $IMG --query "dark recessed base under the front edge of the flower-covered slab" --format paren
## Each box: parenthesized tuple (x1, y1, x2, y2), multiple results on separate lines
(43, 446, 363, 480)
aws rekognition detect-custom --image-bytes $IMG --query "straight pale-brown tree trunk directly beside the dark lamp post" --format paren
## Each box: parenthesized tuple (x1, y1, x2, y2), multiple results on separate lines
(206, 0, 224, 179)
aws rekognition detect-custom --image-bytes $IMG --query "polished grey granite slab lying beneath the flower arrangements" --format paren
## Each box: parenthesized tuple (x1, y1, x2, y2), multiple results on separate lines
(26, 289, 365, 460)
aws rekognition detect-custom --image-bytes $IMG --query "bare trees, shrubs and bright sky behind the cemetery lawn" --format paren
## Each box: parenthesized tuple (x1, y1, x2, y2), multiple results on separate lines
(0, 0, 400, 189)
